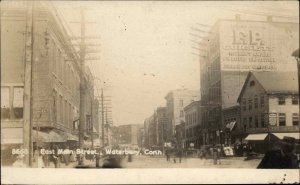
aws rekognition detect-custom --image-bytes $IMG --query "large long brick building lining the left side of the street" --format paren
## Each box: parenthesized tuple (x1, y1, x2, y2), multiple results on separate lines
(1, 1, 99, 165)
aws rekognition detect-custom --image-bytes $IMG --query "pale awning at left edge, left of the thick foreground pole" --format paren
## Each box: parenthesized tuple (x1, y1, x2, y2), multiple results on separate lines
(1, 128, 23, 144)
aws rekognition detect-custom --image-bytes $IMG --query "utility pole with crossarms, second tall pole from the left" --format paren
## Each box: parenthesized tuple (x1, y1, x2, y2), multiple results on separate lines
(78, 8, 86, 165)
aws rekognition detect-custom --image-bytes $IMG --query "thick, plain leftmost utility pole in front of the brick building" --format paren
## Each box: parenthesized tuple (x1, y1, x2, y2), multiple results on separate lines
(23, 1, 34, 167)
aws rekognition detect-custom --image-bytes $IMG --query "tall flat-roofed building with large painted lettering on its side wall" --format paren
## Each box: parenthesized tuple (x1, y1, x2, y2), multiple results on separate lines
(200, 16, 299, 143)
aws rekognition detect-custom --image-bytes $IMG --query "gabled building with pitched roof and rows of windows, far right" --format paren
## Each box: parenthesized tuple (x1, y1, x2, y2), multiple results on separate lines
(236, 72, 299, 151)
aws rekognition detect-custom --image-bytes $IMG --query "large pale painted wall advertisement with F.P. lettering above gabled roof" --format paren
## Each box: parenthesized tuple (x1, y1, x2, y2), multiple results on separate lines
(220, 21, 299, 71)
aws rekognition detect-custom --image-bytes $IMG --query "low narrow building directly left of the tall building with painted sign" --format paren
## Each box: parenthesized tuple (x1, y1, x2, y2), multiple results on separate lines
(184, 101, 203, 148)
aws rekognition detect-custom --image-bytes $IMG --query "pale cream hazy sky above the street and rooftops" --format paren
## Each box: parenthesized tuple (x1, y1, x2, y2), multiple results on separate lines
(55, 1, 299, 125)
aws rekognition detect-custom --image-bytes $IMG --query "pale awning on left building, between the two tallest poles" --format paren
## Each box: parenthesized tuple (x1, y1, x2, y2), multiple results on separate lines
(32, 130, 66, 143)
